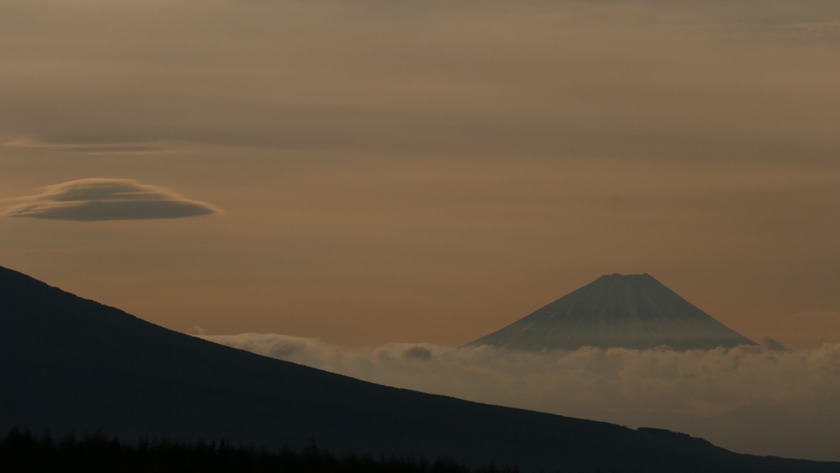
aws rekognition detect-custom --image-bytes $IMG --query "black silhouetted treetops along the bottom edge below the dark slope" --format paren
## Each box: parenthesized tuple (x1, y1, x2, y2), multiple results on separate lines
(0, 428, 532, 473)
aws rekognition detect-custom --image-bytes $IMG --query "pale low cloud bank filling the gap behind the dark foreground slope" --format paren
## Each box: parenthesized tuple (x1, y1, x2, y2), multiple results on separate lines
(202, 333, 840, 461)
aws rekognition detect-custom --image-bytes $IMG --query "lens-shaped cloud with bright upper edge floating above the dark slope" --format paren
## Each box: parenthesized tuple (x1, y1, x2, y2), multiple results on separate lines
(4, 178, 218, 222)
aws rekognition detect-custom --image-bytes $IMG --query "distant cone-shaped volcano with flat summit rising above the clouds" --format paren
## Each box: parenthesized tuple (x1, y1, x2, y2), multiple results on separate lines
(466, 273, 755, 351)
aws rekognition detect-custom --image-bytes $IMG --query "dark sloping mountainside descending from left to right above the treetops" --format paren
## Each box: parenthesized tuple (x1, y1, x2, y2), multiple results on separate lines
(0, 268, 840, 473)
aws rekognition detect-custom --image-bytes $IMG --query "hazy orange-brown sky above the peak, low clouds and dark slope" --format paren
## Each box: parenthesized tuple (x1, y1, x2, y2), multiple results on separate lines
(0, 0, 840, 347)
